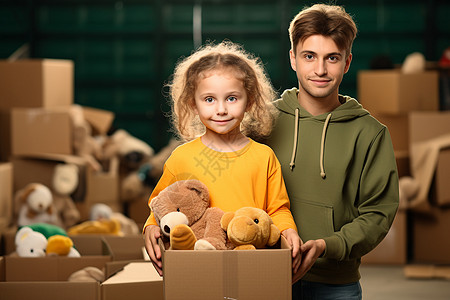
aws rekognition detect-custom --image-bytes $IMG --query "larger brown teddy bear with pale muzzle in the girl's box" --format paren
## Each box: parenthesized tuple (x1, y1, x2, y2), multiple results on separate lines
(150, 179, 227, 250)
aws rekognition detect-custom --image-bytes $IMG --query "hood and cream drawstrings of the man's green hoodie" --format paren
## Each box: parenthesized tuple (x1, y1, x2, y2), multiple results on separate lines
(275, 88, 369, 179)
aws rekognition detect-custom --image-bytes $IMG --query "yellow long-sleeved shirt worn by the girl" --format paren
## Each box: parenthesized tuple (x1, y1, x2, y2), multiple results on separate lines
(144, 138, 297, 231)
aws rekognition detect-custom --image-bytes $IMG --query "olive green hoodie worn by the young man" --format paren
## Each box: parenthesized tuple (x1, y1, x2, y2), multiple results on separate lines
(267, 88, 398, 284)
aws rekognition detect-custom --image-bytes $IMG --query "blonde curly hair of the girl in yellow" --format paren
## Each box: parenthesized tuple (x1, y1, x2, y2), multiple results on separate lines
(168, 41, 277, 141)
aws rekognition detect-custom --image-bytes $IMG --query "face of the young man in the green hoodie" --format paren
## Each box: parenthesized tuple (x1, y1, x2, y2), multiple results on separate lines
(290, 35, 352, 100)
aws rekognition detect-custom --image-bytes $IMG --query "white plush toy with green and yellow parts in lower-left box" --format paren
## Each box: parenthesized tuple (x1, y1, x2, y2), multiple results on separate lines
(15, 226, 80, 257)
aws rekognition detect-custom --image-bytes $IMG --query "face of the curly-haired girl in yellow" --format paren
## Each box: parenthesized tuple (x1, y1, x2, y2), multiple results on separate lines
(194, 70, 247, 139)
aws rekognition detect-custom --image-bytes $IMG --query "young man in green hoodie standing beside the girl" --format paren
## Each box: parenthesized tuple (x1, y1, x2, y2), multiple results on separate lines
(267, 4, 398, 300)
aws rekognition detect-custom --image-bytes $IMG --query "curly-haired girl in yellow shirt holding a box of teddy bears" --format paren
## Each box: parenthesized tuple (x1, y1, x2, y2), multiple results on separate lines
(144, 42, 300, 275)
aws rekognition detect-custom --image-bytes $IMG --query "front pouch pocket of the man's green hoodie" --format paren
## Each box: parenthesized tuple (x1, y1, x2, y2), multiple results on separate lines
(295, 201, 334, 242)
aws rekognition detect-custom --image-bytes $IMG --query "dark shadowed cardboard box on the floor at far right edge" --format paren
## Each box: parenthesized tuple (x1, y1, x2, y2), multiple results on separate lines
(412, 207, 450, 264)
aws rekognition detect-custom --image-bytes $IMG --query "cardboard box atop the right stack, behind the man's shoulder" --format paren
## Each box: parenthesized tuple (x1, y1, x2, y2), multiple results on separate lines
(357, 70, 439, 114)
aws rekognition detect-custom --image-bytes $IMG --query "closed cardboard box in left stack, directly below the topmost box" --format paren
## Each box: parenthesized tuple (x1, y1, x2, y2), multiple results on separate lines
(11, 108, 73, 155)
